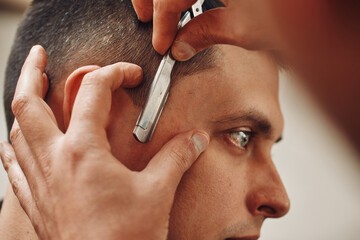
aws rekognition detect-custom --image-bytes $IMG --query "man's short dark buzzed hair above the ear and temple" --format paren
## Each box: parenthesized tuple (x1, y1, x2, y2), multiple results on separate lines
(4, 0, 223, 133)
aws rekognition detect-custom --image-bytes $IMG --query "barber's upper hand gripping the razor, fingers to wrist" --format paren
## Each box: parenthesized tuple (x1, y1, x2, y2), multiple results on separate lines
(132, 0, 280, 61)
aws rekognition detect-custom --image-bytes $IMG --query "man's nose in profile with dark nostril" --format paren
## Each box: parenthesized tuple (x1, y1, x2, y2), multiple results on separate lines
(246, 158, 290, 218)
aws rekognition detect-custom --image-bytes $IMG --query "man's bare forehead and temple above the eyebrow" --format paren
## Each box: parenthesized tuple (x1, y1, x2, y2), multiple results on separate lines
(167, 45, 281, 131)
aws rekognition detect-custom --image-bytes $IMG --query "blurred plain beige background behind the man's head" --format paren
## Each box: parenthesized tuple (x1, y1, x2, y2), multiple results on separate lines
(0, 0, 360, 240)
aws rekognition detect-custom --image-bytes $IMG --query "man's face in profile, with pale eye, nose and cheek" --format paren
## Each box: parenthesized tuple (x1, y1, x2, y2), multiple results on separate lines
(105, 46, 289, 240)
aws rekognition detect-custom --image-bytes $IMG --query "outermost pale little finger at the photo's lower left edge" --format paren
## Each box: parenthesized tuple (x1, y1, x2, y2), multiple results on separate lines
(0, 142, 47, 239)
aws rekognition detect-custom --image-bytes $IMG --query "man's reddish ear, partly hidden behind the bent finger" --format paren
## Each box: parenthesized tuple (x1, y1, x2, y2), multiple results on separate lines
(63, 65, 100, 129)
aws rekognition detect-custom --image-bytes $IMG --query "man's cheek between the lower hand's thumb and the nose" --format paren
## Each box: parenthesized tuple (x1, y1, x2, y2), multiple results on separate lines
(170, 140, 246, 239)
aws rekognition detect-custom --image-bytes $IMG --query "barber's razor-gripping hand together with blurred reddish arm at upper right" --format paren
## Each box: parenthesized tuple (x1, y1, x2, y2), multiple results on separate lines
(133, 0, 360, 149)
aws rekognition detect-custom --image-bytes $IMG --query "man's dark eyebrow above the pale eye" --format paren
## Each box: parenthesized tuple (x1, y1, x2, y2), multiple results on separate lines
(213, 110, 282, 143)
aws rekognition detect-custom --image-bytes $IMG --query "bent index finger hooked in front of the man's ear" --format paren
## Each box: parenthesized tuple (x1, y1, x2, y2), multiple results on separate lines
(68, 63, 142, 143)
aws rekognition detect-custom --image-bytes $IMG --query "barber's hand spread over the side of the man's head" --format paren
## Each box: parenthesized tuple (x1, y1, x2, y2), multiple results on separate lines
(0, 47, 209, 239)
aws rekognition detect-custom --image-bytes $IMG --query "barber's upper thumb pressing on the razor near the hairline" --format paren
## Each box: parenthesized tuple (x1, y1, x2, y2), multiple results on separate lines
(171, 8, 235, 61)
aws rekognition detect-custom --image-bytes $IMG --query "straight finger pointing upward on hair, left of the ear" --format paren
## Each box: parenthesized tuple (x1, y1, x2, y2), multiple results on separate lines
(12, 46, 61, 153)
